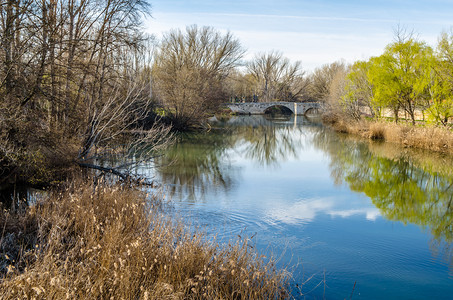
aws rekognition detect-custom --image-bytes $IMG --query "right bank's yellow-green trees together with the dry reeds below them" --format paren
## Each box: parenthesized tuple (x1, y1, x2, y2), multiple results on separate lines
(315, 28, 453, 154)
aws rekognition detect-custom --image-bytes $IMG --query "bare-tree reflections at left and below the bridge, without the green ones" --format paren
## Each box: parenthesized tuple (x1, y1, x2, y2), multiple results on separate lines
(156, 116, 307, 201)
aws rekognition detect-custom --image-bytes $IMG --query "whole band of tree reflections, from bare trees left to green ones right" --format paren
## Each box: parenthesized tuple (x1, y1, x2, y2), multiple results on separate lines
(157, 116, 453, 262)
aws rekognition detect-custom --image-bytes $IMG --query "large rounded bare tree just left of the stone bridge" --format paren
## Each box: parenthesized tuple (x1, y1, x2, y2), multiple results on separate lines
(153, 25, 244, 129)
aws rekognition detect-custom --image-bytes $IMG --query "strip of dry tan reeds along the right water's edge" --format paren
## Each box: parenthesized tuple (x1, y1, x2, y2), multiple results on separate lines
(322, 114, 453, 153)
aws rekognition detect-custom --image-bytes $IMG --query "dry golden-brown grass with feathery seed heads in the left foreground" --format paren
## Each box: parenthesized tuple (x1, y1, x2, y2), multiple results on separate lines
(0, 180, 288, 299)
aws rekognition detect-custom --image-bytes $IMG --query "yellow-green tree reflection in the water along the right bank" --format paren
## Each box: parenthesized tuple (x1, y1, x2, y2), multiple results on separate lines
(314, 130, 453, 264)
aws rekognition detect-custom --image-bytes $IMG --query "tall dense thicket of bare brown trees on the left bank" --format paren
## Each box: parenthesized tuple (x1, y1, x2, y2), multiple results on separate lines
(0, 0, 172, 181)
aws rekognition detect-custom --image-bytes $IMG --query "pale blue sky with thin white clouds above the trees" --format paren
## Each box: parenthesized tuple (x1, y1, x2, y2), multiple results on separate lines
(146, 0, 453, 71)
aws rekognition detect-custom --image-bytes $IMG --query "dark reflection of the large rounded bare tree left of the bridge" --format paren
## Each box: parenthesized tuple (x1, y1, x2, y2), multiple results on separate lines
(156, 130, 239, 201)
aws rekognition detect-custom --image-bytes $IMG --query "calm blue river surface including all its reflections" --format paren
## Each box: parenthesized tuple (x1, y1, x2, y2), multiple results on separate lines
(149, 116, 453, 299)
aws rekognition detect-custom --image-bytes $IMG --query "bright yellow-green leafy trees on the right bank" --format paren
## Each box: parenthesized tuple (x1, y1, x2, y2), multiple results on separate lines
(340, 33, 453, 126)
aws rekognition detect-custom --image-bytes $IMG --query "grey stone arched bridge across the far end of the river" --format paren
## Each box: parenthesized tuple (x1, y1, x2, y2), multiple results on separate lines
(227, 102, 320, 115)
